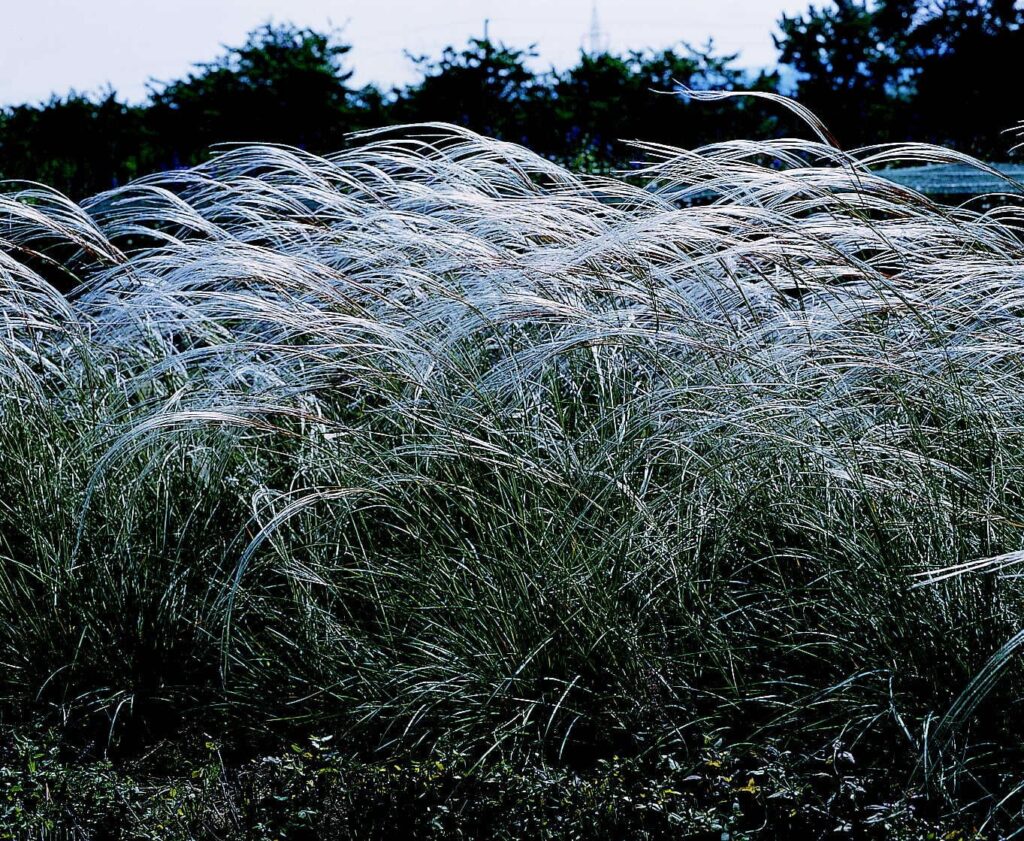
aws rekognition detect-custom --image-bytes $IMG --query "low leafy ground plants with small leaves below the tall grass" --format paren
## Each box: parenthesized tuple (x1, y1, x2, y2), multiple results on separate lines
(0, 730, 972, 841)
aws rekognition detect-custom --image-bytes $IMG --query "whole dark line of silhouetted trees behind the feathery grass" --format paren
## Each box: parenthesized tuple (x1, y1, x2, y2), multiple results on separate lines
(0, 0, 1024, 198)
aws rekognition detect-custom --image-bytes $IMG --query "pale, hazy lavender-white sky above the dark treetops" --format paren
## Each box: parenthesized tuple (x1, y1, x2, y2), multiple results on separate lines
(0, 0, 820, 104)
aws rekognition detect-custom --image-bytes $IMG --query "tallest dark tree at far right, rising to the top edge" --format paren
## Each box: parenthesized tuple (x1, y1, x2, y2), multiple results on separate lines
(775, 0, 1024, 158)
